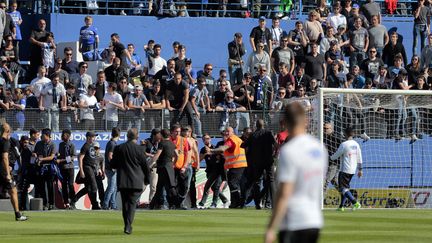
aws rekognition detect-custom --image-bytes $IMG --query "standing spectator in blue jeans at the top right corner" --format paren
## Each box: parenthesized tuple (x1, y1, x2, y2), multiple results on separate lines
(412, 0, 432, 54)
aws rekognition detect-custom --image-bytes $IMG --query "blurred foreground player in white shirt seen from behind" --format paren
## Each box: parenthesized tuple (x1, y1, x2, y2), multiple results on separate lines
(265, 102, 328, 243)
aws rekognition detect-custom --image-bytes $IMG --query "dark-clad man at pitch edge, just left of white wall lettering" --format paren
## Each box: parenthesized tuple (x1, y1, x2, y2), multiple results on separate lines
(33, 128, 55, 210)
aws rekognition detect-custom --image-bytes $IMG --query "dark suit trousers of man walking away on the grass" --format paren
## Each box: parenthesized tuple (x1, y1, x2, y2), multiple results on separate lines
(120, 189, 142, 229)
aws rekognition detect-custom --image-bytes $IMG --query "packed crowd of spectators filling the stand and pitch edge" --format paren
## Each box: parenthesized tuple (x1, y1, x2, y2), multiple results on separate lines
(0, 0, 432, 215)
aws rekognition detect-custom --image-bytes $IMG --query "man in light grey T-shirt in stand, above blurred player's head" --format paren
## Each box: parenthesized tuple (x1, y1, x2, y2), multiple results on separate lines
(271, 35, 295, 89)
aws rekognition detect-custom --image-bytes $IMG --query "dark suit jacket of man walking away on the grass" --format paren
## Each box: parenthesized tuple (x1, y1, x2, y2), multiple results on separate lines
(110, 141, 150, 190)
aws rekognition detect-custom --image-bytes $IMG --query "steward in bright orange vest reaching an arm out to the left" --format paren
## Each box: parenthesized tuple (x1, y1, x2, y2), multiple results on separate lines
(208, 127, 247, 208)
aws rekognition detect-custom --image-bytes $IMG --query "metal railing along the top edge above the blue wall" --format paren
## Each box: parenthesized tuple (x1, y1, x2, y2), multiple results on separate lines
(14, 0, 417, 19)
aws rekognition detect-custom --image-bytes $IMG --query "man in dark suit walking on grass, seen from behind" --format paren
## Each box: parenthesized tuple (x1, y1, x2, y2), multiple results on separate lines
(110, 128, 150, 234)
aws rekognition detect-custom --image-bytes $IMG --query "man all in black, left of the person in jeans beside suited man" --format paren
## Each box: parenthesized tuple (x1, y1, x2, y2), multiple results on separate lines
(74, 131, 100, 210)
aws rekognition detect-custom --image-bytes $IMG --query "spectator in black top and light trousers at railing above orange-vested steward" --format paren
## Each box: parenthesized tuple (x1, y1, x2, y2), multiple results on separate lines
(233, 73, 255, 131)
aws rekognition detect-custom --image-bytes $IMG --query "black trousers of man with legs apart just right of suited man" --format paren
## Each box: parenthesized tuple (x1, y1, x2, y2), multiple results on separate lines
(151, 168, 179, 208)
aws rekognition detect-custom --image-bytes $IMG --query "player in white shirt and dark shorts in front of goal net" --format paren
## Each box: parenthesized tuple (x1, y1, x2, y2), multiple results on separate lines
(330, 127, 363, 211)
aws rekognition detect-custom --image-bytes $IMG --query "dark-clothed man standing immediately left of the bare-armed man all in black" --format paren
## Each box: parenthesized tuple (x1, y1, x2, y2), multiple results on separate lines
(57, 129, 75, 209)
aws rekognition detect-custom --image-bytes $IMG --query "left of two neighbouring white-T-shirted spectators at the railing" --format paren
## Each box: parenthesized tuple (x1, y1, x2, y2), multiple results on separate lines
(79, 84, 98, 131)
